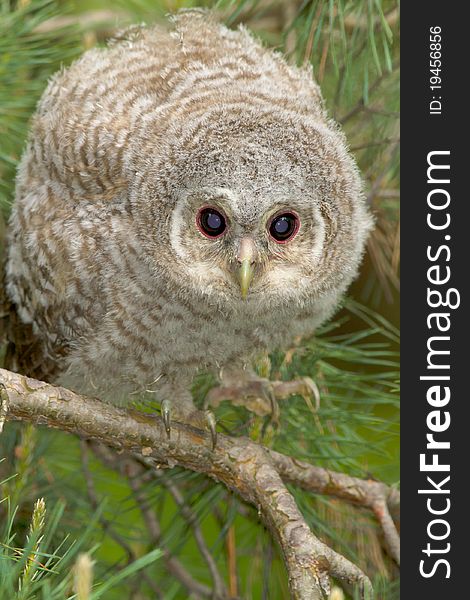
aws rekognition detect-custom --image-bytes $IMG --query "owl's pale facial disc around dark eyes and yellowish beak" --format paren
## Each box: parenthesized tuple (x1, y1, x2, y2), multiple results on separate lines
(174, 192, 310, 310)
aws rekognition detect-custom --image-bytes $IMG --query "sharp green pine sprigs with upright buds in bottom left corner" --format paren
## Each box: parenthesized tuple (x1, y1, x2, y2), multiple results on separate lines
(0, 464, 161, 600)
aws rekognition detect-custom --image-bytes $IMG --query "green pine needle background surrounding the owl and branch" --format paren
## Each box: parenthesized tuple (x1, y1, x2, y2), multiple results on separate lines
(0, 0, 399, 600)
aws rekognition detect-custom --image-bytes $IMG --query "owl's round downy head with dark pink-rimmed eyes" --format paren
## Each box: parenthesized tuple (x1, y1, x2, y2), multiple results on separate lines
(130, 108, 371, 313)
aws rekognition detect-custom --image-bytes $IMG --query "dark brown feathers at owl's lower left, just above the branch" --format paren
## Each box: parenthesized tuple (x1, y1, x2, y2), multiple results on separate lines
(0, 265, 68, 381)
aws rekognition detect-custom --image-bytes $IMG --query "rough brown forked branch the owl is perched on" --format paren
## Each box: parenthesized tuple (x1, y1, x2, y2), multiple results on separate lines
(0, 369, 396, 600)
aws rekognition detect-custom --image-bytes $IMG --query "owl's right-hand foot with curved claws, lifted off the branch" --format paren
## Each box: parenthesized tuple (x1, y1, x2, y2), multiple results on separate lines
(206, 371, 320, 424)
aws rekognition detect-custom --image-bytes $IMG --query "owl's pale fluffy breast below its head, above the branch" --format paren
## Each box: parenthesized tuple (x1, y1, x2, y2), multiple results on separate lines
(57, 247, 326, 401)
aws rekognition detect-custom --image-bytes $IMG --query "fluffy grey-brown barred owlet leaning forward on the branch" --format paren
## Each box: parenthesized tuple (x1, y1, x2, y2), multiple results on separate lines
(1, 10, 372, 440)
